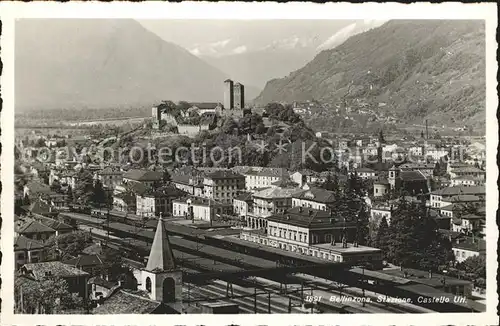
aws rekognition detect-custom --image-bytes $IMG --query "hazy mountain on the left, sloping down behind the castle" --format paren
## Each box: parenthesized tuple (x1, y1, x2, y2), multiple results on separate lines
(15, 19, 227, 110)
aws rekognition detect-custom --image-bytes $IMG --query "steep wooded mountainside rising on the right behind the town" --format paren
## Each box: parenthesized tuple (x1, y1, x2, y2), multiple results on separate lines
(255, 20, 486, 128)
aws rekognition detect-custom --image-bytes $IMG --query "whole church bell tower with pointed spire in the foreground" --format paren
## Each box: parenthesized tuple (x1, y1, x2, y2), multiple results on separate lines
(141, 215, 182, 312)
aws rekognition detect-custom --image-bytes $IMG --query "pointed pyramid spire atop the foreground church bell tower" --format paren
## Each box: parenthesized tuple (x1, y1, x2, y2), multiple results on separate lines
(146, 213, 176, 271)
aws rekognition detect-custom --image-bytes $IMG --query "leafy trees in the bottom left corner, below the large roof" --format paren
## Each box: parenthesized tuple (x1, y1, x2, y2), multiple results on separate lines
(14, 277, 83, 314)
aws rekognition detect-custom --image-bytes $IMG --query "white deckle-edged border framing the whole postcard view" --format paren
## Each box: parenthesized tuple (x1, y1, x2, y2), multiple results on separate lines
(0, 2, 498, 325)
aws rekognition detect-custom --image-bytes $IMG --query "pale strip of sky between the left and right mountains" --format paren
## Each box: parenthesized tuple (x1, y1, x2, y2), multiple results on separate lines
(139, 20, 362, 56)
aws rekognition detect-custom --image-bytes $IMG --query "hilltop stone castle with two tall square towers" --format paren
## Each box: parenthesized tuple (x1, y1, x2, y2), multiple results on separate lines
(151, 79, 250, 137)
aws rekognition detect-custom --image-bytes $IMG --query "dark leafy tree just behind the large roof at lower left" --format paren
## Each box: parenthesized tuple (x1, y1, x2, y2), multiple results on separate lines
(45, 231, 92, 260)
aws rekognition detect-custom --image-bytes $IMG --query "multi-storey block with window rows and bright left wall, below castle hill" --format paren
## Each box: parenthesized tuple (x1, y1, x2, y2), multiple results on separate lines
(203, 170, 245, 204)
